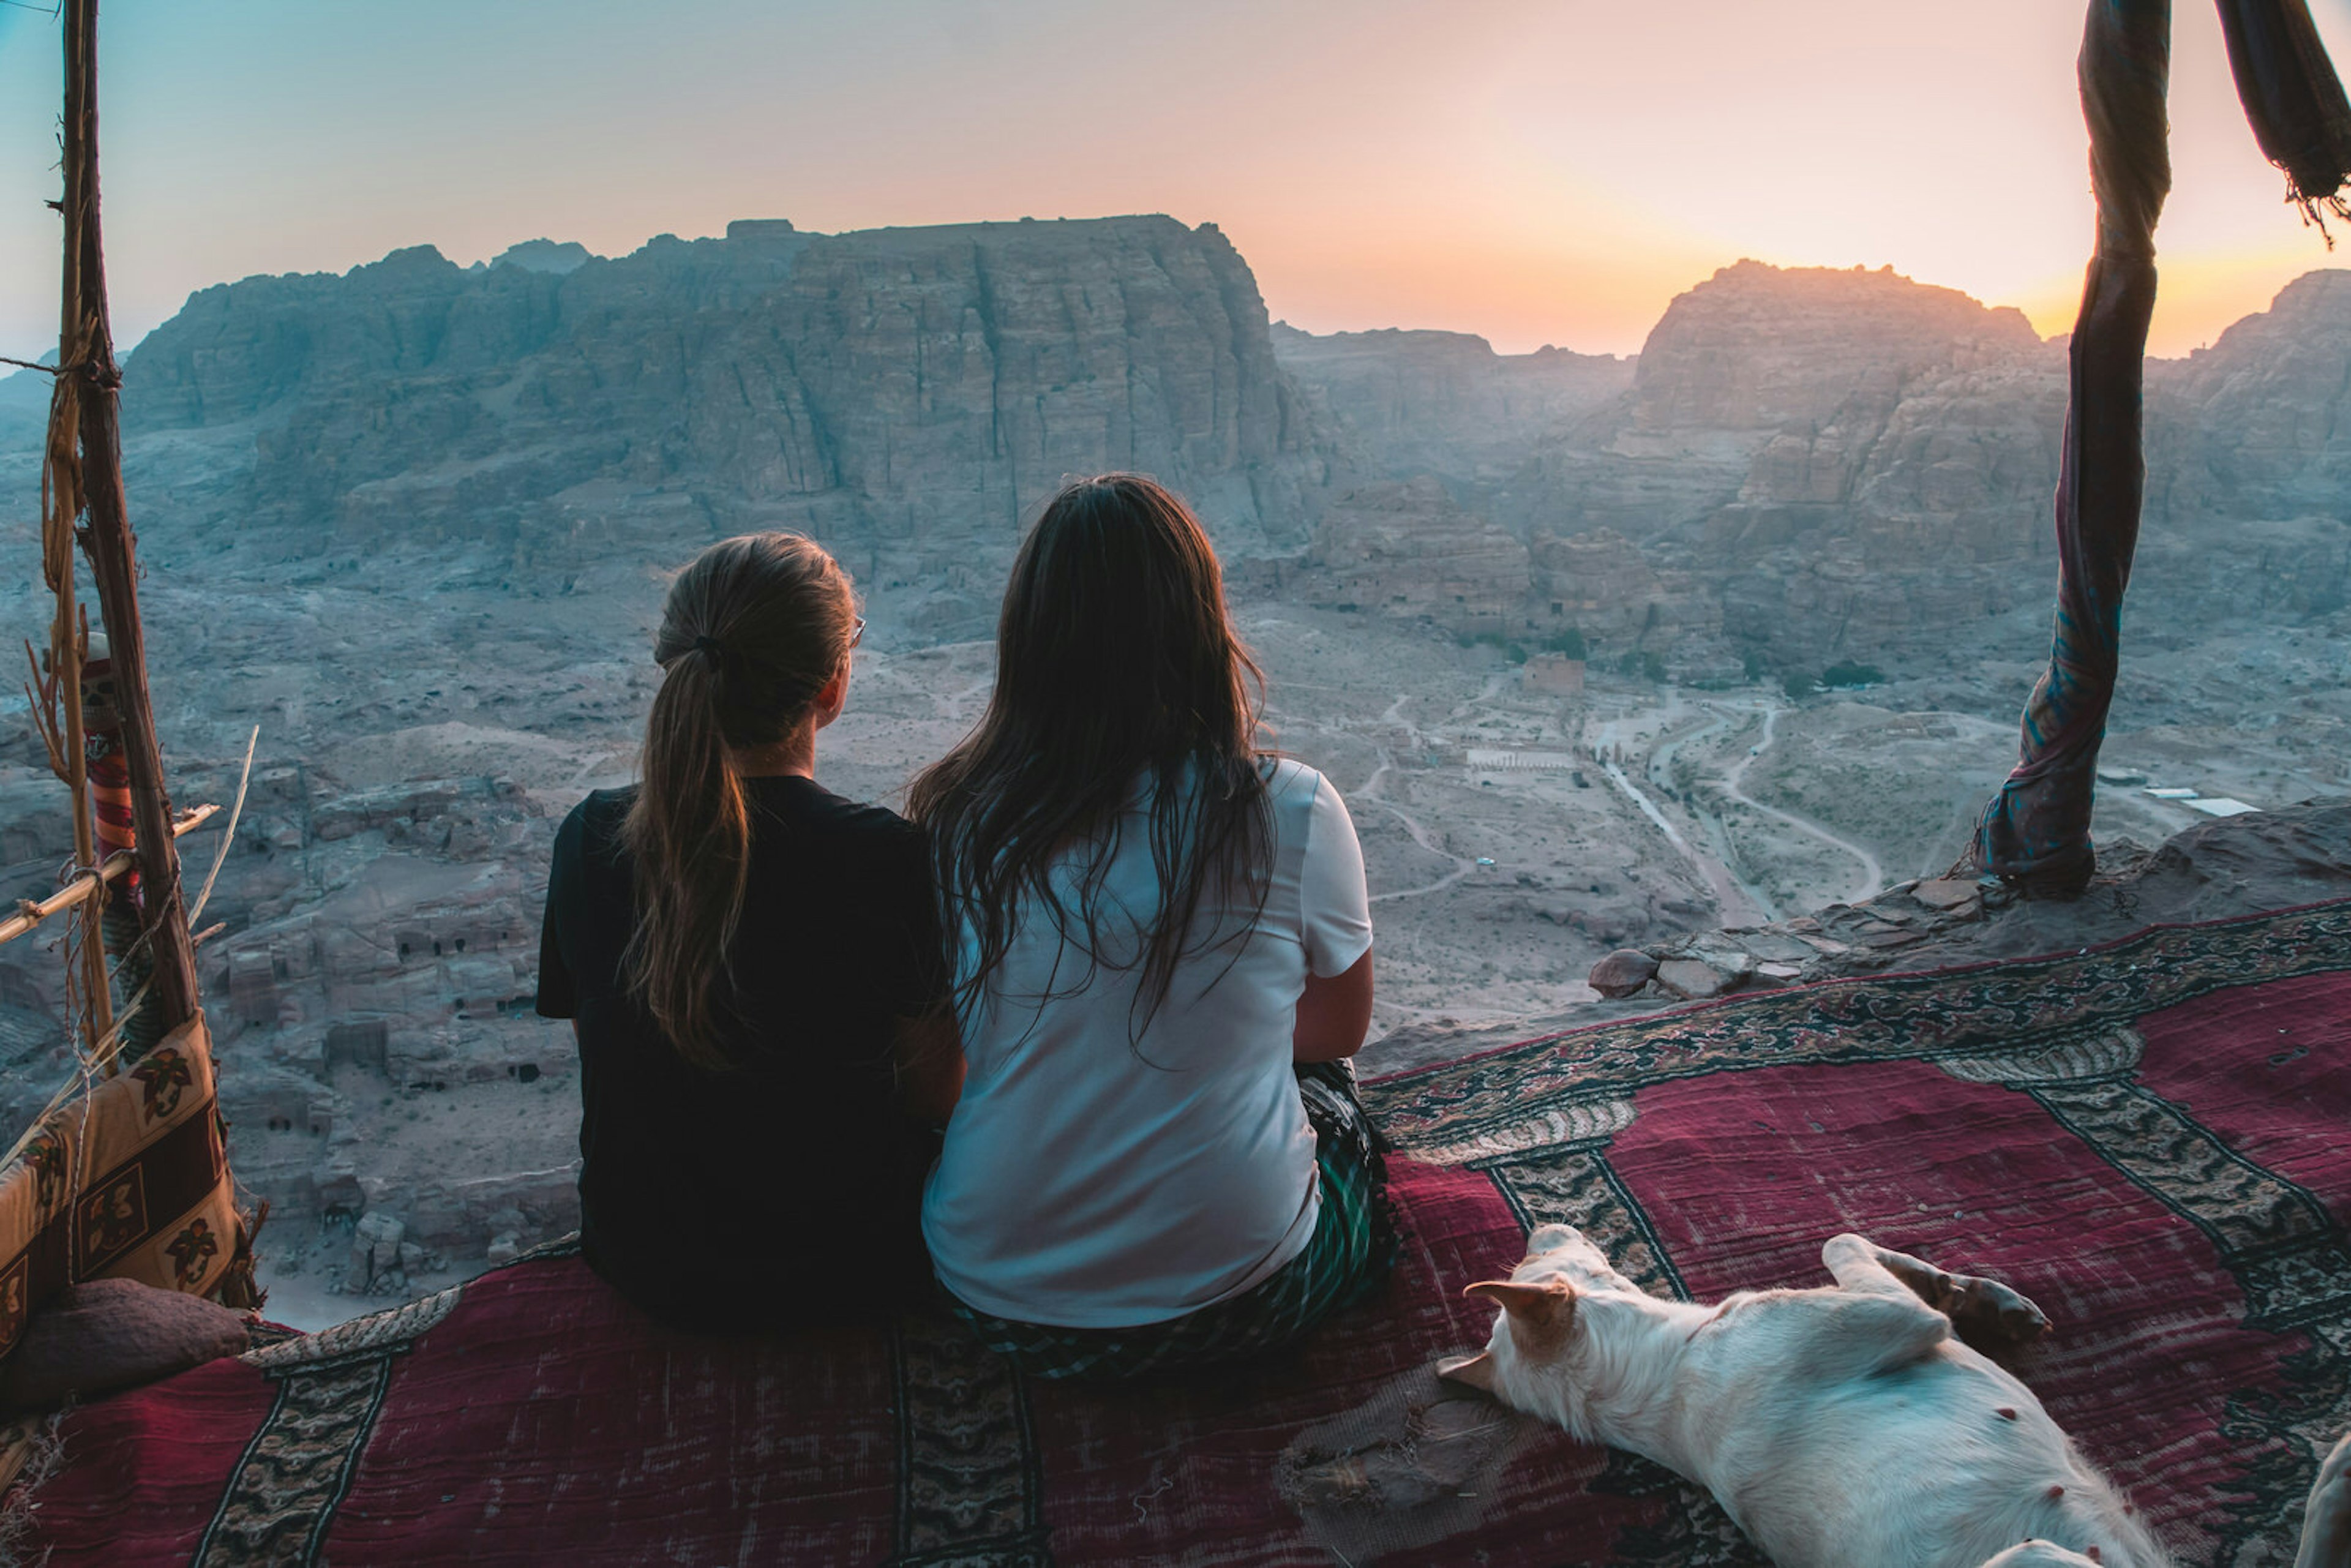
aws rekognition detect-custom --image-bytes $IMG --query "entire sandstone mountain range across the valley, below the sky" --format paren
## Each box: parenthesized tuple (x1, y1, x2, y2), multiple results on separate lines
(18, 234, 2351, 672)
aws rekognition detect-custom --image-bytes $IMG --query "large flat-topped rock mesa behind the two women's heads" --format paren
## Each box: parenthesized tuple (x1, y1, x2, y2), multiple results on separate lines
(127, 216, 1321, 571)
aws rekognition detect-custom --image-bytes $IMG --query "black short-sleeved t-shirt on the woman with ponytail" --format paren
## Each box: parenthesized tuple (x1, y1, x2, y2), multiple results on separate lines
(538, 776, 948, 1328)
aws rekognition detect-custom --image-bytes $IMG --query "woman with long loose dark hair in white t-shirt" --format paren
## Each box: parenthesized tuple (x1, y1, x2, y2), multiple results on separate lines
(910, 475, 1389, 1378)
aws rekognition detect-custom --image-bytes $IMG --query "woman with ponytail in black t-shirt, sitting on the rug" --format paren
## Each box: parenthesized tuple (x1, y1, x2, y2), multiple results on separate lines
(538, 534, 962, 1328)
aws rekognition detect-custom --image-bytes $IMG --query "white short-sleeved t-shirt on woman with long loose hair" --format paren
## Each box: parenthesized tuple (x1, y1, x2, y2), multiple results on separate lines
(921, 759, 1371, 1328)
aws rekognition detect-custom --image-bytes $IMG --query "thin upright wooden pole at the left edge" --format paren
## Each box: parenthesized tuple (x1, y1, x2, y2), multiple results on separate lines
(56, 0, 198, 1030)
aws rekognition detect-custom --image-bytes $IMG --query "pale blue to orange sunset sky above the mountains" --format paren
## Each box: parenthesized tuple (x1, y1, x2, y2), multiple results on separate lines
(0, 0, 2351, 358)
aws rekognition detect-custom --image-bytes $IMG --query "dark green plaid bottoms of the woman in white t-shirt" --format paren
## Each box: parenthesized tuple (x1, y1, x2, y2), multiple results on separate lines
(950, 1062, 1397, 1380)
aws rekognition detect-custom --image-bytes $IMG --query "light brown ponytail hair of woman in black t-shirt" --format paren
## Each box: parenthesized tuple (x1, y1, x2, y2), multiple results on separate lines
(621, 534, 858, 1067)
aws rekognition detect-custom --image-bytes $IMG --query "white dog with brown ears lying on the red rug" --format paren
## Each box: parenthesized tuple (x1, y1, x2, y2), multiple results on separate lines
(1439, 1225, 2351, 1568)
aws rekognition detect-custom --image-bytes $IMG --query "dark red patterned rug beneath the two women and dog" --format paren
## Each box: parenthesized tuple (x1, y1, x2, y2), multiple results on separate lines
(12, 905, 2351, 1568)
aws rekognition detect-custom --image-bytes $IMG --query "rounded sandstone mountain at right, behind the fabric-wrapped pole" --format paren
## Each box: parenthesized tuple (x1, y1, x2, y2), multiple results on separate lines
(1509, 261, 2351, 670)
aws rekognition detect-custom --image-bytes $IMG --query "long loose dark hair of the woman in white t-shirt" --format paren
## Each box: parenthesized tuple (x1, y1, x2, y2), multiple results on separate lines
(907, 473, 1272, 1034)
